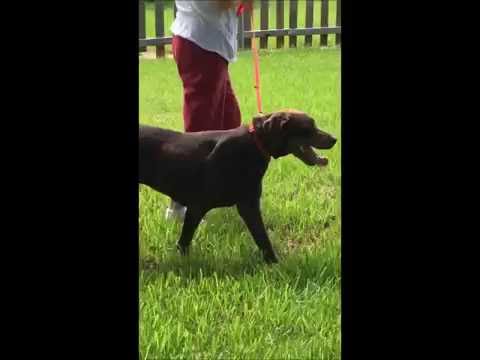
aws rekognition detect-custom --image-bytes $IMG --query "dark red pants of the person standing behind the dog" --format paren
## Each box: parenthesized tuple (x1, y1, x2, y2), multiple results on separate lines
(172, 36, 241, 132)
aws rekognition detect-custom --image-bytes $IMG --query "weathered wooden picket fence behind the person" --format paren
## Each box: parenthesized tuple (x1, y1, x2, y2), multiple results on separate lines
(139, 0, 341, 57)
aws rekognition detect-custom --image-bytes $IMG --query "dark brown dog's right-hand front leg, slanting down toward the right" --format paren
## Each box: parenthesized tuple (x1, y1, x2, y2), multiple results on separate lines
(237, 199, 278, 263)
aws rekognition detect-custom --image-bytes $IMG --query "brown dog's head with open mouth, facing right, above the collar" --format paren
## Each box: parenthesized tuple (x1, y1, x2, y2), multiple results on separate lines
(253, 110, 337, 166)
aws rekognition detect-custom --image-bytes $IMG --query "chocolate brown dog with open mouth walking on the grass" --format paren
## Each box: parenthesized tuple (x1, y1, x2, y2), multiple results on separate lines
(139, 111, 337, 263)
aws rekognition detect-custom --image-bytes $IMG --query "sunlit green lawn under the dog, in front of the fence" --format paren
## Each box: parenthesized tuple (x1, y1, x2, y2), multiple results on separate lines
(139, 48, 341, 359)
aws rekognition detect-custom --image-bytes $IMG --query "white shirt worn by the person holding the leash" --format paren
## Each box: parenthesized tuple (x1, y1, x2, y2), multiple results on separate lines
(171, 0, 238, 62)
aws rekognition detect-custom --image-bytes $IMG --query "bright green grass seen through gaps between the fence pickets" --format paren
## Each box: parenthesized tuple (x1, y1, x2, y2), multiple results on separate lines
(145, 0, 337, 51)
